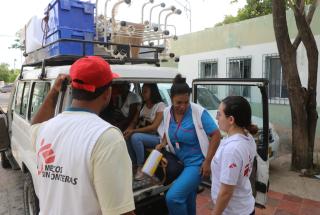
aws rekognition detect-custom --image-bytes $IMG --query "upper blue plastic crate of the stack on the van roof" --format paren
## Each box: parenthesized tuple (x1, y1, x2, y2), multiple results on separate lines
(47, 0, 95, 34)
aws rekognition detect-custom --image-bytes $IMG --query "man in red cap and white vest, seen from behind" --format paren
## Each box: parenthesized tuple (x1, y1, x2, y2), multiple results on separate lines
(32, 56, 135, 215)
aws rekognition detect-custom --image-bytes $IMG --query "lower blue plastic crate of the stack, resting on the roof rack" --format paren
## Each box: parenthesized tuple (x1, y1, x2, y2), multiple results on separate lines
(46, 28, 94, 57)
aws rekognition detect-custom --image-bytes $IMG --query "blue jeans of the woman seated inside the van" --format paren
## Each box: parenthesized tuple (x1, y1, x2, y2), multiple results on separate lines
(128, 133, 160, 166)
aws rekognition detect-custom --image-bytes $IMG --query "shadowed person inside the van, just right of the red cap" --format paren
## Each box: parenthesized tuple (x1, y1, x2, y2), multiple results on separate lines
(100, 82, 141, 131)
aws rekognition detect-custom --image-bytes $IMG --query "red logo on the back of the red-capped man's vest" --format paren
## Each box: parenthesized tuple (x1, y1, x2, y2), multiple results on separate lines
(37, 139, 55, 175)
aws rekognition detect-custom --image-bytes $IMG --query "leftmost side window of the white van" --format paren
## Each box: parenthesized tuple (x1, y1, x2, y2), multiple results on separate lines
(15, 82, 30, 118)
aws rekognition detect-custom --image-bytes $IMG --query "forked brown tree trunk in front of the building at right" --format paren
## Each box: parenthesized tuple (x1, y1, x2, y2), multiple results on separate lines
(272, 0, 318, 169)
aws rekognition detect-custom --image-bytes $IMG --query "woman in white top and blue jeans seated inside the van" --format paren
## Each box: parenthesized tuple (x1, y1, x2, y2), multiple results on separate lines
(124, 84, 165, 180)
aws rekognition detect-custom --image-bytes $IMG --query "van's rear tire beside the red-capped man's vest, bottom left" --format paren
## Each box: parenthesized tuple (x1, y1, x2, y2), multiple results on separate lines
(23, 173, 39, 215)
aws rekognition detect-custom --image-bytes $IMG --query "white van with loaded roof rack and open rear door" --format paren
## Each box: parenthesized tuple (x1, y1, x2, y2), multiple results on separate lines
(0, 59, 269, 214)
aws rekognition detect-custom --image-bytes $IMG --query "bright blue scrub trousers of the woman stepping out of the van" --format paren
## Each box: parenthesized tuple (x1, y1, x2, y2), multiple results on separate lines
(166, 166, 201, 215)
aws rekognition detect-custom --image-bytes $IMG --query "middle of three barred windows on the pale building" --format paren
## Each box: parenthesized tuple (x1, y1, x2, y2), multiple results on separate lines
(227, 57, 251, 98)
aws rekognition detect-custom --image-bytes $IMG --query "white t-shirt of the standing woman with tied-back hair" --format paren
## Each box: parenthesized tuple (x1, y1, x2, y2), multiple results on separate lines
(211, 134, 257, 215)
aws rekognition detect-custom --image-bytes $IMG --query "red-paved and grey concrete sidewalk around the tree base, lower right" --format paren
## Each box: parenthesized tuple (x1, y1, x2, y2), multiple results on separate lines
(197, 154, 320, 215)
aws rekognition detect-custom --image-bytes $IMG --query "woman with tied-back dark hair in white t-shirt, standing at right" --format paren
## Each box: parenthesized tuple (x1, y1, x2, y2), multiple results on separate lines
(211, 96, 258, 215)
